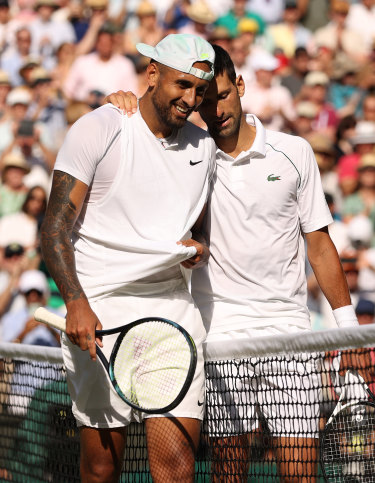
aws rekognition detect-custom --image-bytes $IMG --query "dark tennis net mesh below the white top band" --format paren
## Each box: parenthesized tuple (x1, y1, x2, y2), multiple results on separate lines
(0, 326, 375, 482)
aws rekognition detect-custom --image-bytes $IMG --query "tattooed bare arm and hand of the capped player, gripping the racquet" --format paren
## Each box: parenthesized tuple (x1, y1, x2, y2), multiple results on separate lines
(41, 171, 102, 360)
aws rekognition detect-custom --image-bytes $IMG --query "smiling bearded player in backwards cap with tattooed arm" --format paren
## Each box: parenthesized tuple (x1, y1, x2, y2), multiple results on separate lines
(41, 34, 215, 483)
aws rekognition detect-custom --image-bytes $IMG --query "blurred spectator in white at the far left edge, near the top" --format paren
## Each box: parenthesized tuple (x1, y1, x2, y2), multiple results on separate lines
(0, 26, 31, 87)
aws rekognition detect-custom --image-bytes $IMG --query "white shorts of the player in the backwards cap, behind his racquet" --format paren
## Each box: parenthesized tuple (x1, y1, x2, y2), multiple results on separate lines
(62, 280, 206, 428)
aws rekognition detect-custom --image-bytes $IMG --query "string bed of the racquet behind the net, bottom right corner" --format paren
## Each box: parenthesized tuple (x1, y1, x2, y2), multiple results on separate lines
(322, 403, 375, 483)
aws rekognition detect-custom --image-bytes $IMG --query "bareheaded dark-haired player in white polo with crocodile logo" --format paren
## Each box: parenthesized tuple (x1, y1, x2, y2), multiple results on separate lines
(107, 46, 358, 483)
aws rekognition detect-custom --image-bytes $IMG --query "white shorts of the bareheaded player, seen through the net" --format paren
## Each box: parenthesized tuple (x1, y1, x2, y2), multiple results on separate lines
(205, 330, 321, 438)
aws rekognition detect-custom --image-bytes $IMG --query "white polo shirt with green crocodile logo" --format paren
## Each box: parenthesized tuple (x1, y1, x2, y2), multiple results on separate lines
(192, 115, 332, 333)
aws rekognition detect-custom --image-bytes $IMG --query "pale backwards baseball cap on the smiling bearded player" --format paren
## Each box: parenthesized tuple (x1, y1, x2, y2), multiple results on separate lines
(136, 34, 215, 81)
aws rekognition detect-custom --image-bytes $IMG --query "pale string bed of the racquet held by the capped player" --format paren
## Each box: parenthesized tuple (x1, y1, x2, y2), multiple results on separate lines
(113, 321, 191, 410)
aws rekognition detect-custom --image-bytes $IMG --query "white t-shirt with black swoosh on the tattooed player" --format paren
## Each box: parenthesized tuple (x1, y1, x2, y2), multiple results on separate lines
(55, 105, 215, 297)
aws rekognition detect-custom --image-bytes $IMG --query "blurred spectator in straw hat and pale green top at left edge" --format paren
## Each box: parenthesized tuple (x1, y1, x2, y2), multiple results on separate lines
(0, 152, 30, 217)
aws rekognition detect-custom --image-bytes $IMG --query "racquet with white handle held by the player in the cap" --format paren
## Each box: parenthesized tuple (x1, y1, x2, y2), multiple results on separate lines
(34, 307, 197, 414)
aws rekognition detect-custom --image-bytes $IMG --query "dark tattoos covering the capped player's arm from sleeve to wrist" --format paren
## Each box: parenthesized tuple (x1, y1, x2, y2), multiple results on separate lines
(41, 171, 84, 302)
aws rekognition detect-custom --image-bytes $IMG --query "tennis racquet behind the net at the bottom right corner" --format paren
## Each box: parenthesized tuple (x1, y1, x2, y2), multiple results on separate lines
(320, 370, 375, 483)
